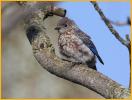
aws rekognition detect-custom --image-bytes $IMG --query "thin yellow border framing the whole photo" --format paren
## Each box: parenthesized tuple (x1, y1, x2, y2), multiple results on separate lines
(0, 0, 132, 100)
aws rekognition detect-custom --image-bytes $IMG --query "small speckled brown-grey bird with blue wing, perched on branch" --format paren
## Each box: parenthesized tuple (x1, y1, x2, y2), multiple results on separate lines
(55, 17, 104, 70)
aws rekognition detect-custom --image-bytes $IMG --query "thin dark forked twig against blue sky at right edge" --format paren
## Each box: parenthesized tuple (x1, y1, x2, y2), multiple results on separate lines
(91, 1, 131, 88)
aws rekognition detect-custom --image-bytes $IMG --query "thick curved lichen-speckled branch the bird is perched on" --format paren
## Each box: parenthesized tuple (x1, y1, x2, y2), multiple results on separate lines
(25, 5, 130, 98)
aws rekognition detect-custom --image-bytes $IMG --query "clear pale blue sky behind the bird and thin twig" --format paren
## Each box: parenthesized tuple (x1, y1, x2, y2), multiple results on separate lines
(59, 2, 130, 87)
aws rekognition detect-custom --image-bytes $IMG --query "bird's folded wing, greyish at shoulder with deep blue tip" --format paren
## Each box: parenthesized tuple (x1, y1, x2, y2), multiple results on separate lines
(75, 29, 104, 64)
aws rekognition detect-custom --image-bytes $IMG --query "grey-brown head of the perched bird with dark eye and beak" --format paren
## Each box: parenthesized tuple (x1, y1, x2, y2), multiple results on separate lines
(55, 17, 75, 33)
